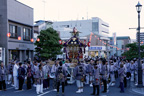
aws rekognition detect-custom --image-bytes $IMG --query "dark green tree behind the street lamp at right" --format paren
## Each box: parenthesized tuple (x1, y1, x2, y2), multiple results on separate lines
(122, 43, 144, 60)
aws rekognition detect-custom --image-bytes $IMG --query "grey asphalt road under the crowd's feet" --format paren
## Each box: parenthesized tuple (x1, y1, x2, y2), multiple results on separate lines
(0, 81, 143, 96)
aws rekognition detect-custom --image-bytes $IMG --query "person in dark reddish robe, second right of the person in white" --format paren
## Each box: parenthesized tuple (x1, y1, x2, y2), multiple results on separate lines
(27, 61, 32, 90)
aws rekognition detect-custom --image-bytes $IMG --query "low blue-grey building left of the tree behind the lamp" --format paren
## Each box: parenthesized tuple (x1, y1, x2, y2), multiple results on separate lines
(109, 36, 131, 56)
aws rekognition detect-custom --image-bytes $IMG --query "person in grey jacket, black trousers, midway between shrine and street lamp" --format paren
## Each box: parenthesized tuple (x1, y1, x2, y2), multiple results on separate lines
(101, 59, 108, 93)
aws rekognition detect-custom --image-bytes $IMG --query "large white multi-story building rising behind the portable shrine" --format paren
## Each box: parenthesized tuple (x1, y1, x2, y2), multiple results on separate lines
(53, 17, 109, 38)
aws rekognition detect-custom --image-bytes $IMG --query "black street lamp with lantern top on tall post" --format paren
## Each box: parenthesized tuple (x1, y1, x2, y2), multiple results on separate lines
(136, 2, 142, 87)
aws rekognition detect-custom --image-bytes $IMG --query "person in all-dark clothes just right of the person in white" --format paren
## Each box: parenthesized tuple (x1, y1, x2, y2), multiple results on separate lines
(18, 62, 25, 90)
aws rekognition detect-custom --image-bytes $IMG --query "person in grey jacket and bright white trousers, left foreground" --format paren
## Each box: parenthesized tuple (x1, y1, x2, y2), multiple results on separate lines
(36, 64, 44, 94)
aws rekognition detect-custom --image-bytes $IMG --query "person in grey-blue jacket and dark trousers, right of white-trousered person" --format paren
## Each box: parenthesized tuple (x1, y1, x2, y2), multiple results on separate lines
(43, 61, 50, 90)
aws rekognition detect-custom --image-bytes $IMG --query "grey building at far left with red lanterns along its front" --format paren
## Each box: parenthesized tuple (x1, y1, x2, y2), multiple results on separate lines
(0, 0, 33, 64)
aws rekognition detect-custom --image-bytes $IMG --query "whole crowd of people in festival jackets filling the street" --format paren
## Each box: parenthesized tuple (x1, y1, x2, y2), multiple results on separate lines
(0, 58, 144, 95)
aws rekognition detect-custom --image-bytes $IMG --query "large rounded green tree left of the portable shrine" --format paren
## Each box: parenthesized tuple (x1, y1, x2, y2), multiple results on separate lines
(35, 28, 62, 59)
